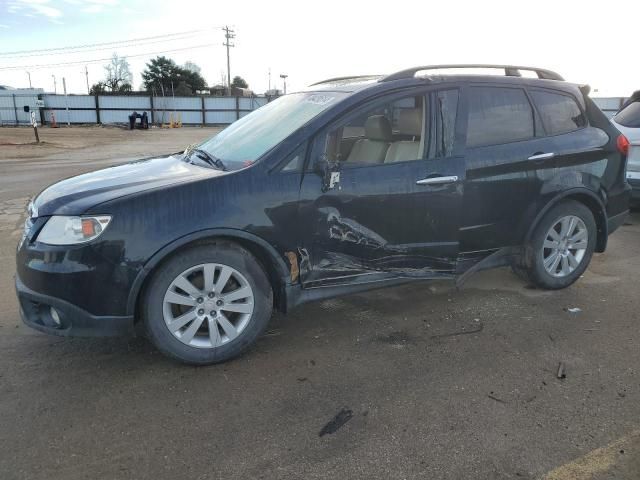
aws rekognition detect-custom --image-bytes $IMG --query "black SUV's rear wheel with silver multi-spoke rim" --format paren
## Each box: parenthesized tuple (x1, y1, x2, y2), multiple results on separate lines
(519, 200, 597, 290)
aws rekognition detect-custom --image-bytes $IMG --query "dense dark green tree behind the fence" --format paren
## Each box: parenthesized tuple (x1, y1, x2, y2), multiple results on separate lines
(142, 56, 207, 95)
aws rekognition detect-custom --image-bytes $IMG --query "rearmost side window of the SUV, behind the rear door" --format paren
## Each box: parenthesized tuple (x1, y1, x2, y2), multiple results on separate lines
(531, 90, 587, 135)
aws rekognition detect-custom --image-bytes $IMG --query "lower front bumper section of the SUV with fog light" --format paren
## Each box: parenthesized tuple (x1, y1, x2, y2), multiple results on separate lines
(16, 275, 135, 337)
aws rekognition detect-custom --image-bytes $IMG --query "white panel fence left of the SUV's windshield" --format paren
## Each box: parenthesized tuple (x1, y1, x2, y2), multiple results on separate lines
(0, 93, 270, 125)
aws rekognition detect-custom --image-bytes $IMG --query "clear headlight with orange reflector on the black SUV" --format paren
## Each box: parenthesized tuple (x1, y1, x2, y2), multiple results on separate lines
(37, 215, 111, 245)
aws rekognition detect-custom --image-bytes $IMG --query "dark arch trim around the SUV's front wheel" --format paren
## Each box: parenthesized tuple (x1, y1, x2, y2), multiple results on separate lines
(127, 228, 289, 322)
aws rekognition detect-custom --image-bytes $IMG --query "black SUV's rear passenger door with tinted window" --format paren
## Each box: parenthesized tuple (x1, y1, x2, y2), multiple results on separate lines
(460, 83, 555, 256)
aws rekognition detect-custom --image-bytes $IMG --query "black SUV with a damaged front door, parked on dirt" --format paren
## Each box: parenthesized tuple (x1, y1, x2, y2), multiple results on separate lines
(16, 65, 630, 364)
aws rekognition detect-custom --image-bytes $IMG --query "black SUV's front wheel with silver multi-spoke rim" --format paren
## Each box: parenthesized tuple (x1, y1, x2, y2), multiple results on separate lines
(142, 241, 273, 365)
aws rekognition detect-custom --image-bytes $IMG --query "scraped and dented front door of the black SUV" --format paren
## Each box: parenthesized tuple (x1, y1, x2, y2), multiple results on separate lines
(299, 89, 465, 287)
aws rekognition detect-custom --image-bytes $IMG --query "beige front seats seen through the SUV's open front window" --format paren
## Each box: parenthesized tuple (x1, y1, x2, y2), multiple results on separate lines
(346, 102, 425, 164)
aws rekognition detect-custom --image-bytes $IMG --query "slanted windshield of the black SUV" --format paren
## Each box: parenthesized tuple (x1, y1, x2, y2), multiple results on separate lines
(197, 92, 347, 170)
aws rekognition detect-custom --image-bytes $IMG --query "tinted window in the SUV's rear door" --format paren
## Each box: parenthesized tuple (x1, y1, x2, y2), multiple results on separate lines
(467, 87, 534, 147)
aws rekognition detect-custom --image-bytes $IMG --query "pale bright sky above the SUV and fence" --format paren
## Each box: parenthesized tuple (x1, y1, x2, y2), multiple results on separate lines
(0, 0, 640, 96)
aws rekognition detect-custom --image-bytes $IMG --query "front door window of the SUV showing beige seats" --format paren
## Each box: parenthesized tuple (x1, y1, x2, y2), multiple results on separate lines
(317, 96, 425, 167)
